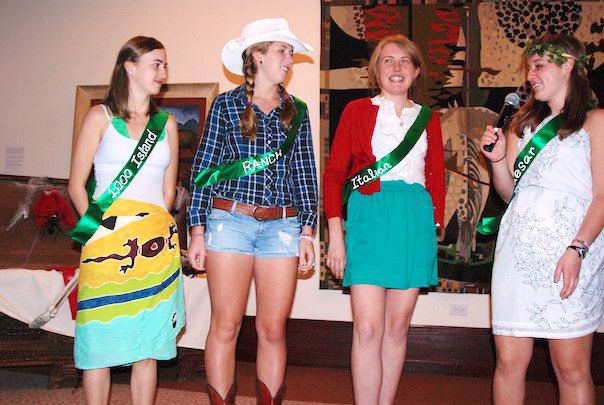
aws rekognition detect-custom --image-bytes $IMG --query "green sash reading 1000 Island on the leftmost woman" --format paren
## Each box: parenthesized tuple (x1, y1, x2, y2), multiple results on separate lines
(69, 111, 169, 244)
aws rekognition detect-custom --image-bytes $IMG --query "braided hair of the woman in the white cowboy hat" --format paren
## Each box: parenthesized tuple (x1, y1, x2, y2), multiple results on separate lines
(239, 42, 297, 141)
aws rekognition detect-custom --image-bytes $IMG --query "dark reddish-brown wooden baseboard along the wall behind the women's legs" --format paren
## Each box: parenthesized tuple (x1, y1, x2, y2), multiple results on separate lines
(237, 316, 604, 385)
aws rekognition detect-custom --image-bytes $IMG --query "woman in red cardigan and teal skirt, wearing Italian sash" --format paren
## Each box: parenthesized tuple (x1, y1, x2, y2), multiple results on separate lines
(323, 35, 445, 404)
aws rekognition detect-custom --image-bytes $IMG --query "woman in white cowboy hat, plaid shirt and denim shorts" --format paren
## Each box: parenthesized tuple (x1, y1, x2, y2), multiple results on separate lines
(188, 18, 317, 404)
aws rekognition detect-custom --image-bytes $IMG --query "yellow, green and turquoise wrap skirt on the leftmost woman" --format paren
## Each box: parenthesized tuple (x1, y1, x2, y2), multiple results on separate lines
(74, 199, 184, 370)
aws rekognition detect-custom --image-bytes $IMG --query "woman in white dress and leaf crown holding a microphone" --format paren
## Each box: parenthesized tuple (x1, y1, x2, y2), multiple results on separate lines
(481, 35, 604, 404)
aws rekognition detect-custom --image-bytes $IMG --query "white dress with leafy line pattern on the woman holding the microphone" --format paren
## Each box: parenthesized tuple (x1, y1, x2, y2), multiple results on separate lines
(491, 117, 604, 339)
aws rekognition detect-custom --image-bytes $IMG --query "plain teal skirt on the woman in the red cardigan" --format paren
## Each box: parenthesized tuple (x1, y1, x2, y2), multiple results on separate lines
(344, 181, 438, 289)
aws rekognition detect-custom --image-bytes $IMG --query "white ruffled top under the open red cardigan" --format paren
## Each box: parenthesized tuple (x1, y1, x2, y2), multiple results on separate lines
(371, 95, 428, 186)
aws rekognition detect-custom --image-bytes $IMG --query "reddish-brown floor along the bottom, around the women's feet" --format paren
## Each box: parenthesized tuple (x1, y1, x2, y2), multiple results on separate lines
(0, 362, 604, 405)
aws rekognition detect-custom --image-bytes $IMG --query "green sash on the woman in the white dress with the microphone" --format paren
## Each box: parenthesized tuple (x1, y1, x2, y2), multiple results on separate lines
(476, 115, 564, 235)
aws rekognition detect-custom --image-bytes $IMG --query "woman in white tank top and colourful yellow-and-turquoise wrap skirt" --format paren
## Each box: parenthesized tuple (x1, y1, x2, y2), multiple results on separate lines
(69, 36, 184, 404)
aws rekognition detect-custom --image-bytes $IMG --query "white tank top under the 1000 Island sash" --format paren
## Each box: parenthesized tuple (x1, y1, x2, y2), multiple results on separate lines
(93, 106, 170, 208)
